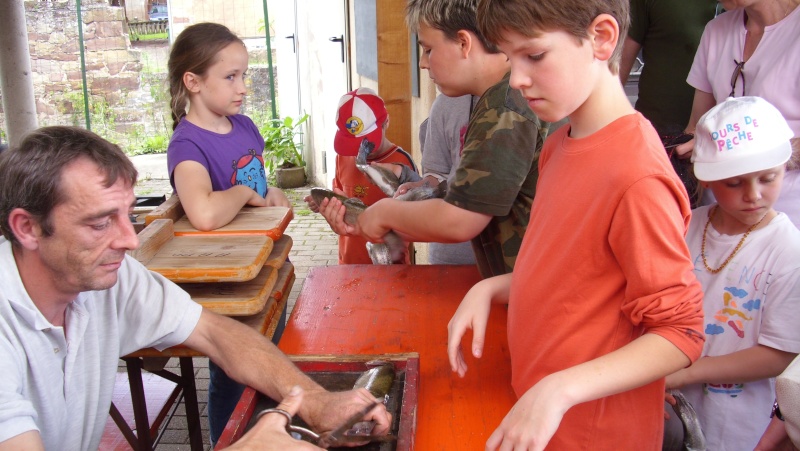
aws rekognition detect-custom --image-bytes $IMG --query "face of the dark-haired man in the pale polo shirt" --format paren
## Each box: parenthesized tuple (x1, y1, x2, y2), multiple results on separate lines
(35, 159, 139, 298)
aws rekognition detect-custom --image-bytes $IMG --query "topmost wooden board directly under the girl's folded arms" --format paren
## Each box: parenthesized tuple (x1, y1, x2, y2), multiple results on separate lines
(175, 207, 294, 240)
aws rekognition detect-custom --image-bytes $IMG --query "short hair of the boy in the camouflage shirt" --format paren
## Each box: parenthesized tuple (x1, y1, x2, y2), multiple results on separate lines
(406, 0, 500, 53)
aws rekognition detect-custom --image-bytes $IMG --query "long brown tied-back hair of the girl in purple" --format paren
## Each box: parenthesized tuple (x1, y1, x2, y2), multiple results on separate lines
(167, 22, 244, 130)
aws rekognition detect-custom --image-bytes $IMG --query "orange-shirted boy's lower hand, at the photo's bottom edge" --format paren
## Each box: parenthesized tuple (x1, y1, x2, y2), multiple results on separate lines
(486, 374, 569, 451)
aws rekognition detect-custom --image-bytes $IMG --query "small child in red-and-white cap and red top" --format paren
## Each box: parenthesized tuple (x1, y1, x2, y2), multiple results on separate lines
(304, 88, 417, 265)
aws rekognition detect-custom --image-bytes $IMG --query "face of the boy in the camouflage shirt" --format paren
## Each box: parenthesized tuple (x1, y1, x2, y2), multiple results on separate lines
(418, 24, 469, 97)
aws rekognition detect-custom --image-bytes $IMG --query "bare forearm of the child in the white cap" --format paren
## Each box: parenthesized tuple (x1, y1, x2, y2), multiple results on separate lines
(667, 345, 797, 388)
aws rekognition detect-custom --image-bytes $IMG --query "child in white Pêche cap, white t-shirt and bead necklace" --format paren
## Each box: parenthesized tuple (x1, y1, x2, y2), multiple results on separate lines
(666, 97, 800, 450)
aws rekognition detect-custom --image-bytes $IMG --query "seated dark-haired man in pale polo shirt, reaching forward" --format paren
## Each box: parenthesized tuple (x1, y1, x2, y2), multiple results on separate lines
(0, 127, 389, 450)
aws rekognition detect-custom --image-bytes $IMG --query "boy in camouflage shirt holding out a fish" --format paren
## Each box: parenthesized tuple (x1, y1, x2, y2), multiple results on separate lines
(320, 0, 548, 277)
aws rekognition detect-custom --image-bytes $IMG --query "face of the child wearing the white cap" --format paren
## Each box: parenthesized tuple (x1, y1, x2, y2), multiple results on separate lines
(703, 166, 784, 230)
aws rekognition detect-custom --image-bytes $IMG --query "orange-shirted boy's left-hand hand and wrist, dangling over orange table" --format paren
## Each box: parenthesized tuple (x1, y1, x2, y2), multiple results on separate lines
(447, 274, 511, 377)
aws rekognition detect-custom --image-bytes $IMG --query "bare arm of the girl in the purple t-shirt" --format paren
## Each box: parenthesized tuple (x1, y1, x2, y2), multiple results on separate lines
(173, 161, 268, 230)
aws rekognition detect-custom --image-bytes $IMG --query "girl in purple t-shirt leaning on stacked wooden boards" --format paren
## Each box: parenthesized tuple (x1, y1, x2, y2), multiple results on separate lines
(167, 23, 291, 230)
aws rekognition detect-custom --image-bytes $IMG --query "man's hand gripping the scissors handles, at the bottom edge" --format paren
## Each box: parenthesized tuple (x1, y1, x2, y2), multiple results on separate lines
(228, 386, 322, 451)
